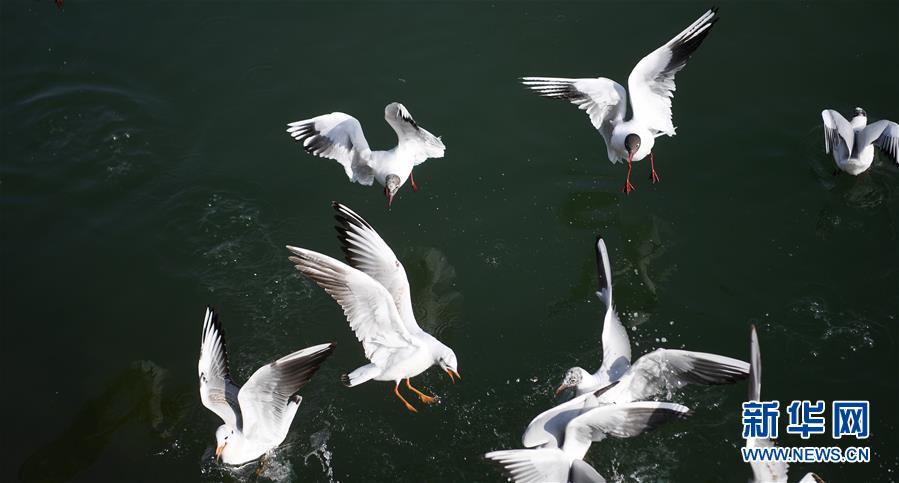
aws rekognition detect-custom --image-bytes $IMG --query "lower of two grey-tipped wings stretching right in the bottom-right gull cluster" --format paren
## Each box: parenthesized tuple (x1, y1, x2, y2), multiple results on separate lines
(562, 401, 690, 459)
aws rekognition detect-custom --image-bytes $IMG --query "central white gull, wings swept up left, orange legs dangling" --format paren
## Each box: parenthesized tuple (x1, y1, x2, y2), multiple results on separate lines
(287, 202, 462, 412)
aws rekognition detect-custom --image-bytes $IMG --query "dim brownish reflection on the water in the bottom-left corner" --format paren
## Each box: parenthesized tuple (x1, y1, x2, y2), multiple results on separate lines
(19, 361, 184, 482)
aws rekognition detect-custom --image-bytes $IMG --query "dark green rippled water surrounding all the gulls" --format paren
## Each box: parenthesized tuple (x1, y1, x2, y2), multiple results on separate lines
(0, 0, 899, 482)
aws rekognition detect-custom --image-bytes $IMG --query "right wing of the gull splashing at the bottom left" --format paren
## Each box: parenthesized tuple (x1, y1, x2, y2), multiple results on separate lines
(237, 343, 334, 444)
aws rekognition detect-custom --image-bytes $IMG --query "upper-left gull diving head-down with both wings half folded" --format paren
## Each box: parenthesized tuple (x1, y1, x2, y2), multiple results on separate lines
(287, 102, 446, 207)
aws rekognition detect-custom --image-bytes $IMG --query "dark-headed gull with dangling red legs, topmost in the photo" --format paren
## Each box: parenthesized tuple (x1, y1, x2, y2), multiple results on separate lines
(521, 8, 718, 193)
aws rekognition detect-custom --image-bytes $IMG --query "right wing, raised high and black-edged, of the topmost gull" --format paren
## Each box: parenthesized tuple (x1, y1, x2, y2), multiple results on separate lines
(627, 8, 718, 136)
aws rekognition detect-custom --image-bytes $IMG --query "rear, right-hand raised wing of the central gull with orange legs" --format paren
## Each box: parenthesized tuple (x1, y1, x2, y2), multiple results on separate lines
(331, 202, 421, 334)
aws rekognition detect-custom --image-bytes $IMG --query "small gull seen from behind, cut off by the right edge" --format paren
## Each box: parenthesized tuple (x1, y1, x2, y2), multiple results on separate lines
(821, 107, 899, 176)
